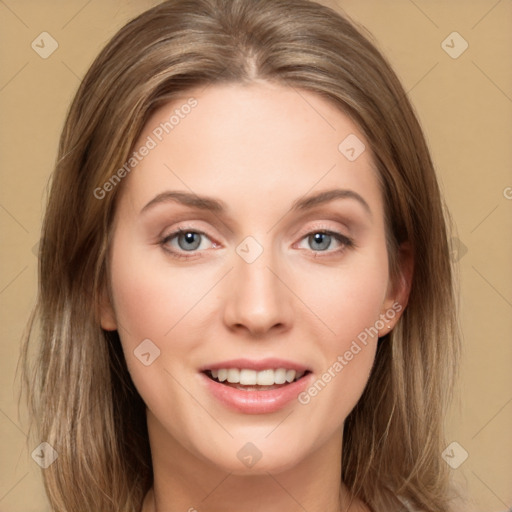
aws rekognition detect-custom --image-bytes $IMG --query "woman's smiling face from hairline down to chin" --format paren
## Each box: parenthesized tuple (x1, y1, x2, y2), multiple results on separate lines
(99, 83, 408, 473)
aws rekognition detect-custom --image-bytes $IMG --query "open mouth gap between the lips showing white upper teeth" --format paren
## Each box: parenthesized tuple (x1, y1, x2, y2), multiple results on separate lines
(203, 368, 311, 391)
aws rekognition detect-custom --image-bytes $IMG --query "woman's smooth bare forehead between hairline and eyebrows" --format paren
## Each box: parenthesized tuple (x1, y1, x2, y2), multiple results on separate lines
(117, 82, 381, 220)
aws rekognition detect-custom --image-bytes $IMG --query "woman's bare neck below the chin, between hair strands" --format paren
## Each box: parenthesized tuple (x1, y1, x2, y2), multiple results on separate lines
(142, 413, 368, 512)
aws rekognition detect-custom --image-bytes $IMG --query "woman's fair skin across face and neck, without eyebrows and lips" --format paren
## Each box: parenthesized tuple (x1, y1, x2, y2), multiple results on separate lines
(101, 82, 409, 512)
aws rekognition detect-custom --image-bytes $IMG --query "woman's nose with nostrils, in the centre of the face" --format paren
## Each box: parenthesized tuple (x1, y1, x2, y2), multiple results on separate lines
(224, 246, 293, 337)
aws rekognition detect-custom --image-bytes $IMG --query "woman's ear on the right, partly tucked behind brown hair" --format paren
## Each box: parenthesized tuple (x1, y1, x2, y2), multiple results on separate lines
(379, 242, 414, 338)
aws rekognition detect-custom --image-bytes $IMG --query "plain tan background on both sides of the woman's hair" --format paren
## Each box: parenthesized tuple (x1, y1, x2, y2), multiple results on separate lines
(0, 0, 512, 512)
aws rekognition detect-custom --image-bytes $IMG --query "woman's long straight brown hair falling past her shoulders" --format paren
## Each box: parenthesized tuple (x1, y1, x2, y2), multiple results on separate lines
(24, 0, 458, 512)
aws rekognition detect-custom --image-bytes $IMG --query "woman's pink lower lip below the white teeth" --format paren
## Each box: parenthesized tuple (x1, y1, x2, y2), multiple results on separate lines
(201, 373, 313, 414)
